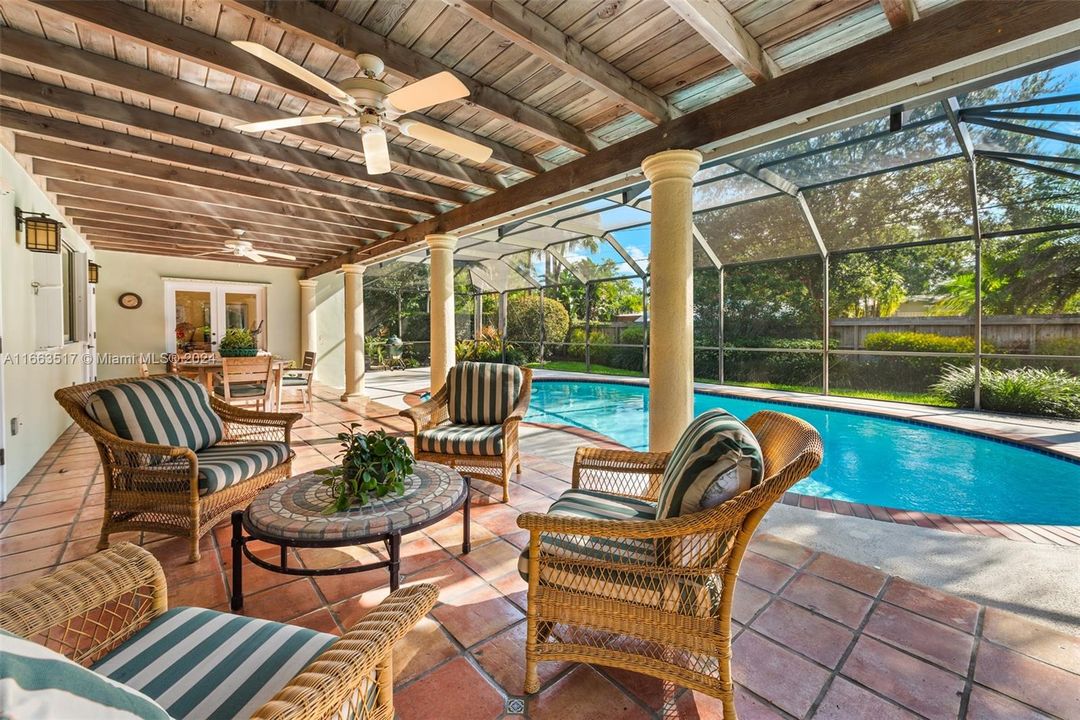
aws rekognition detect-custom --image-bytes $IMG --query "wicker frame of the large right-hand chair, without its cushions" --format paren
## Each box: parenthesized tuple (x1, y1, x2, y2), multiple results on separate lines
(517, 410, 822, 720)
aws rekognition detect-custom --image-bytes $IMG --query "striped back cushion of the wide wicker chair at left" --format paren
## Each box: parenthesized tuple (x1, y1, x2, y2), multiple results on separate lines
(86, 376, 225, 452)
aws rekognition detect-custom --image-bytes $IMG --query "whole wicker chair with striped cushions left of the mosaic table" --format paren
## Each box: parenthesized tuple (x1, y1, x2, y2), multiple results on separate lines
(55, 375, 302, 561)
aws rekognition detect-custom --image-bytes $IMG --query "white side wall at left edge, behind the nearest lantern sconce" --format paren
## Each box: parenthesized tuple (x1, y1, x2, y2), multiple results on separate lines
(0, 138, 93, 491)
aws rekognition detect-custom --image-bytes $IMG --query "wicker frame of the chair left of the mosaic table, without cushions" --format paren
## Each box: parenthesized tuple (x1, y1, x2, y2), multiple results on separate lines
(55, 376, 303, 562)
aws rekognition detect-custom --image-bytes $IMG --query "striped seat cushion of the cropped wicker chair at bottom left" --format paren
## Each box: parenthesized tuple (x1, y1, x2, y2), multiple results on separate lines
(94, 608, 337, 720)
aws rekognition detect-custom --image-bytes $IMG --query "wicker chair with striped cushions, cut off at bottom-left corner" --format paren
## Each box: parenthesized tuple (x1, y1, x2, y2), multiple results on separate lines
(0, 543, 438, 720)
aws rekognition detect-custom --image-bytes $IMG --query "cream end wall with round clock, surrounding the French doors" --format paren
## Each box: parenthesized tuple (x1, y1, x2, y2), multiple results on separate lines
(96, 250, 301, 378)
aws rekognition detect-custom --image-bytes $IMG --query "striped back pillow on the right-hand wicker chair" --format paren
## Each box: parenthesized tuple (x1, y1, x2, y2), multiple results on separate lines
(656, 409, 765, 520)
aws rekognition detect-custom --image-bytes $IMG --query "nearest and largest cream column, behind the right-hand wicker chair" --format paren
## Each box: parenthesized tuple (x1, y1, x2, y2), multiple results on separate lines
(642, 150, 701, 452)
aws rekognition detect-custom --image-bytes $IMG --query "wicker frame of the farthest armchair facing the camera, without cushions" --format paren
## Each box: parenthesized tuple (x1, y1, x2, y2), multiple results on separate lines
(400, 368, 532, 502)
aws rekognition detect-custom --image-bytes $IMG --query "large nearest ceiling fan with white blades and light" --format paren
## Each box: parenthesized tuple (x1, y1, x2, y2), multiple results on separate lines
(232, 40, 491, 175)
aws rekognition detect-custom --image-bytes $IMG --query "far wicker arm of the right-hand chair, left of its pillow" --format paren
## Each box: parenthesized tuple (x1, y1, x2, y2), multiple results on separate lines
(570, 446, 671, 501)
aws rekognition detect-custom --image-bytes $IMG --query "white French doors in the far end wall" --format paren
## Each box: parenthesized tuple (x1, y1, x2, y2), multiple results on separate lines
(165, 280, 267, 353)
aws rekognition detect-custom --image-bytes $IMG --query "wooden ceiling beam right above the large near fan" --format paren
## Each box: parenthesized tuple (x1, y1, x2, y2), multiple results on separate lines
(221, 0, 605, 153)
